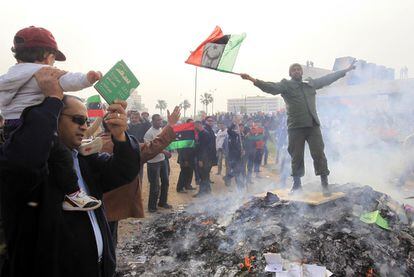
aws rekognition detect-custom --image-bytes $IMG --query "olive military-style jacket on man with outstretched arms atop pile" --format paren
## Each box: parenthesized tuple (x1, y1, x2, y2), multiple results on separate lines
(254, 69, 347, 129)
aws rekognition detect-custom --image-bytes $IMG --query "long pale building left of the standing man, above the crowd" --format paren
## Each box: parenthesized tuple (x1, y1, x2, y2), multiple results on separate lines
(227, 96, 285, 114)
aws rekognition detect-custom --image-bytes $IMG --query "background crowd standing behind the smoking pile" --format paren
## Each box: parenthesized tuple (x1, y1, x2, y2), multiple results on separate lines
(121, 110, 289, 205)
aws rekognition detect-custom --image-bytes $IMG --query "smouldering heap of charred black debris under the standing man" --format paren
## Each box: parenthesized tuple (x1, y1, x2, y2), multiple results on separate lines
(115, 184, 414, 277)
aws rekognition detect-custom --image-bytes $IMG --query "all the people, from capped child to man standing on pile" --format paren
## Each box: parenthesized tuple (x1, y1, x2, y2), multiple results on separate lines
(0, 26, 410, 277)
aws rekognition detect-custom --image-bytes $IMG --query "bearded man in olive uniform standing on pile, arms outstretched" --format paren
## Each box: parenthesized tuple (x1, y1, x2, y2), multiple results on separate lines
(240, 61, 355, 194)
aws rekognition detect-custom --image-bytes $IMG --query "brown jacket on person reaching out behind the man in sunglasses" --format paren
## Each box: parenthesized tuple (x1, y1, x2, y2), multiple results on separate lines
(102, 125, 175, 221)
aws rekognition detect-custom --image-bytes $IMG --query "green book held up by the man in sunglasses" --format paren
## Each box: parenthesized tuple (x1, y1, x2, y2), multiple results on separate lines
(94, 60, 139, 105)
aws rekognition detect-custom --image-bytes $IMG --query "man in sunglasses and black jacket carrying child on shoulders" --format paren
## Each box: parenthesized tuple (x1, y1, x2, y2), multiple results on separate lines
(0, 68, 139, 277)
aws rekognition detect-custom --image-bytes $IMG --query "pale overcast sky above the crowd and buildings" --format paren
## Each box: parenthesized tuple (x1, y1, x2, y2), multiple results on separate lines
(0, 0, 414, 112)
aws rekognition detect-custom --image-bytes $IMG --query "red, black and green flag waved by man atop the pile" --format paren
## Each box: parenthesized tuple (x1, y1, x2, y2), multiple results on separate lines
(186, 26, 246, 72)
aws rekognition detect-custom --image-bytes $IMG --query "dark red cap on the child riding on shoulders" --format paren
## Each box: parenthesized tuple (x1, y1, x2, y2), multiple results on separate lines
(13, 26, 66, 61)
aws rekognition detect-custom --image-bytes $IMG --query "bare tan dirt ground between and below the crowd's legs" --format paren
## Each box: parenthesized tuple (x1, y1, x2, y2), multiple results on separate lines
(118, 153, 278, 244)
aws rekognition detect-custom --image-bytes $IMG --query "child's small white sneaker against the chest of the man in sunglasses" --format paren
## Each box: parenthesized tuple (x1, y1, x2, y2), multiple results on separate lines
(62, 190, 102, 211)
